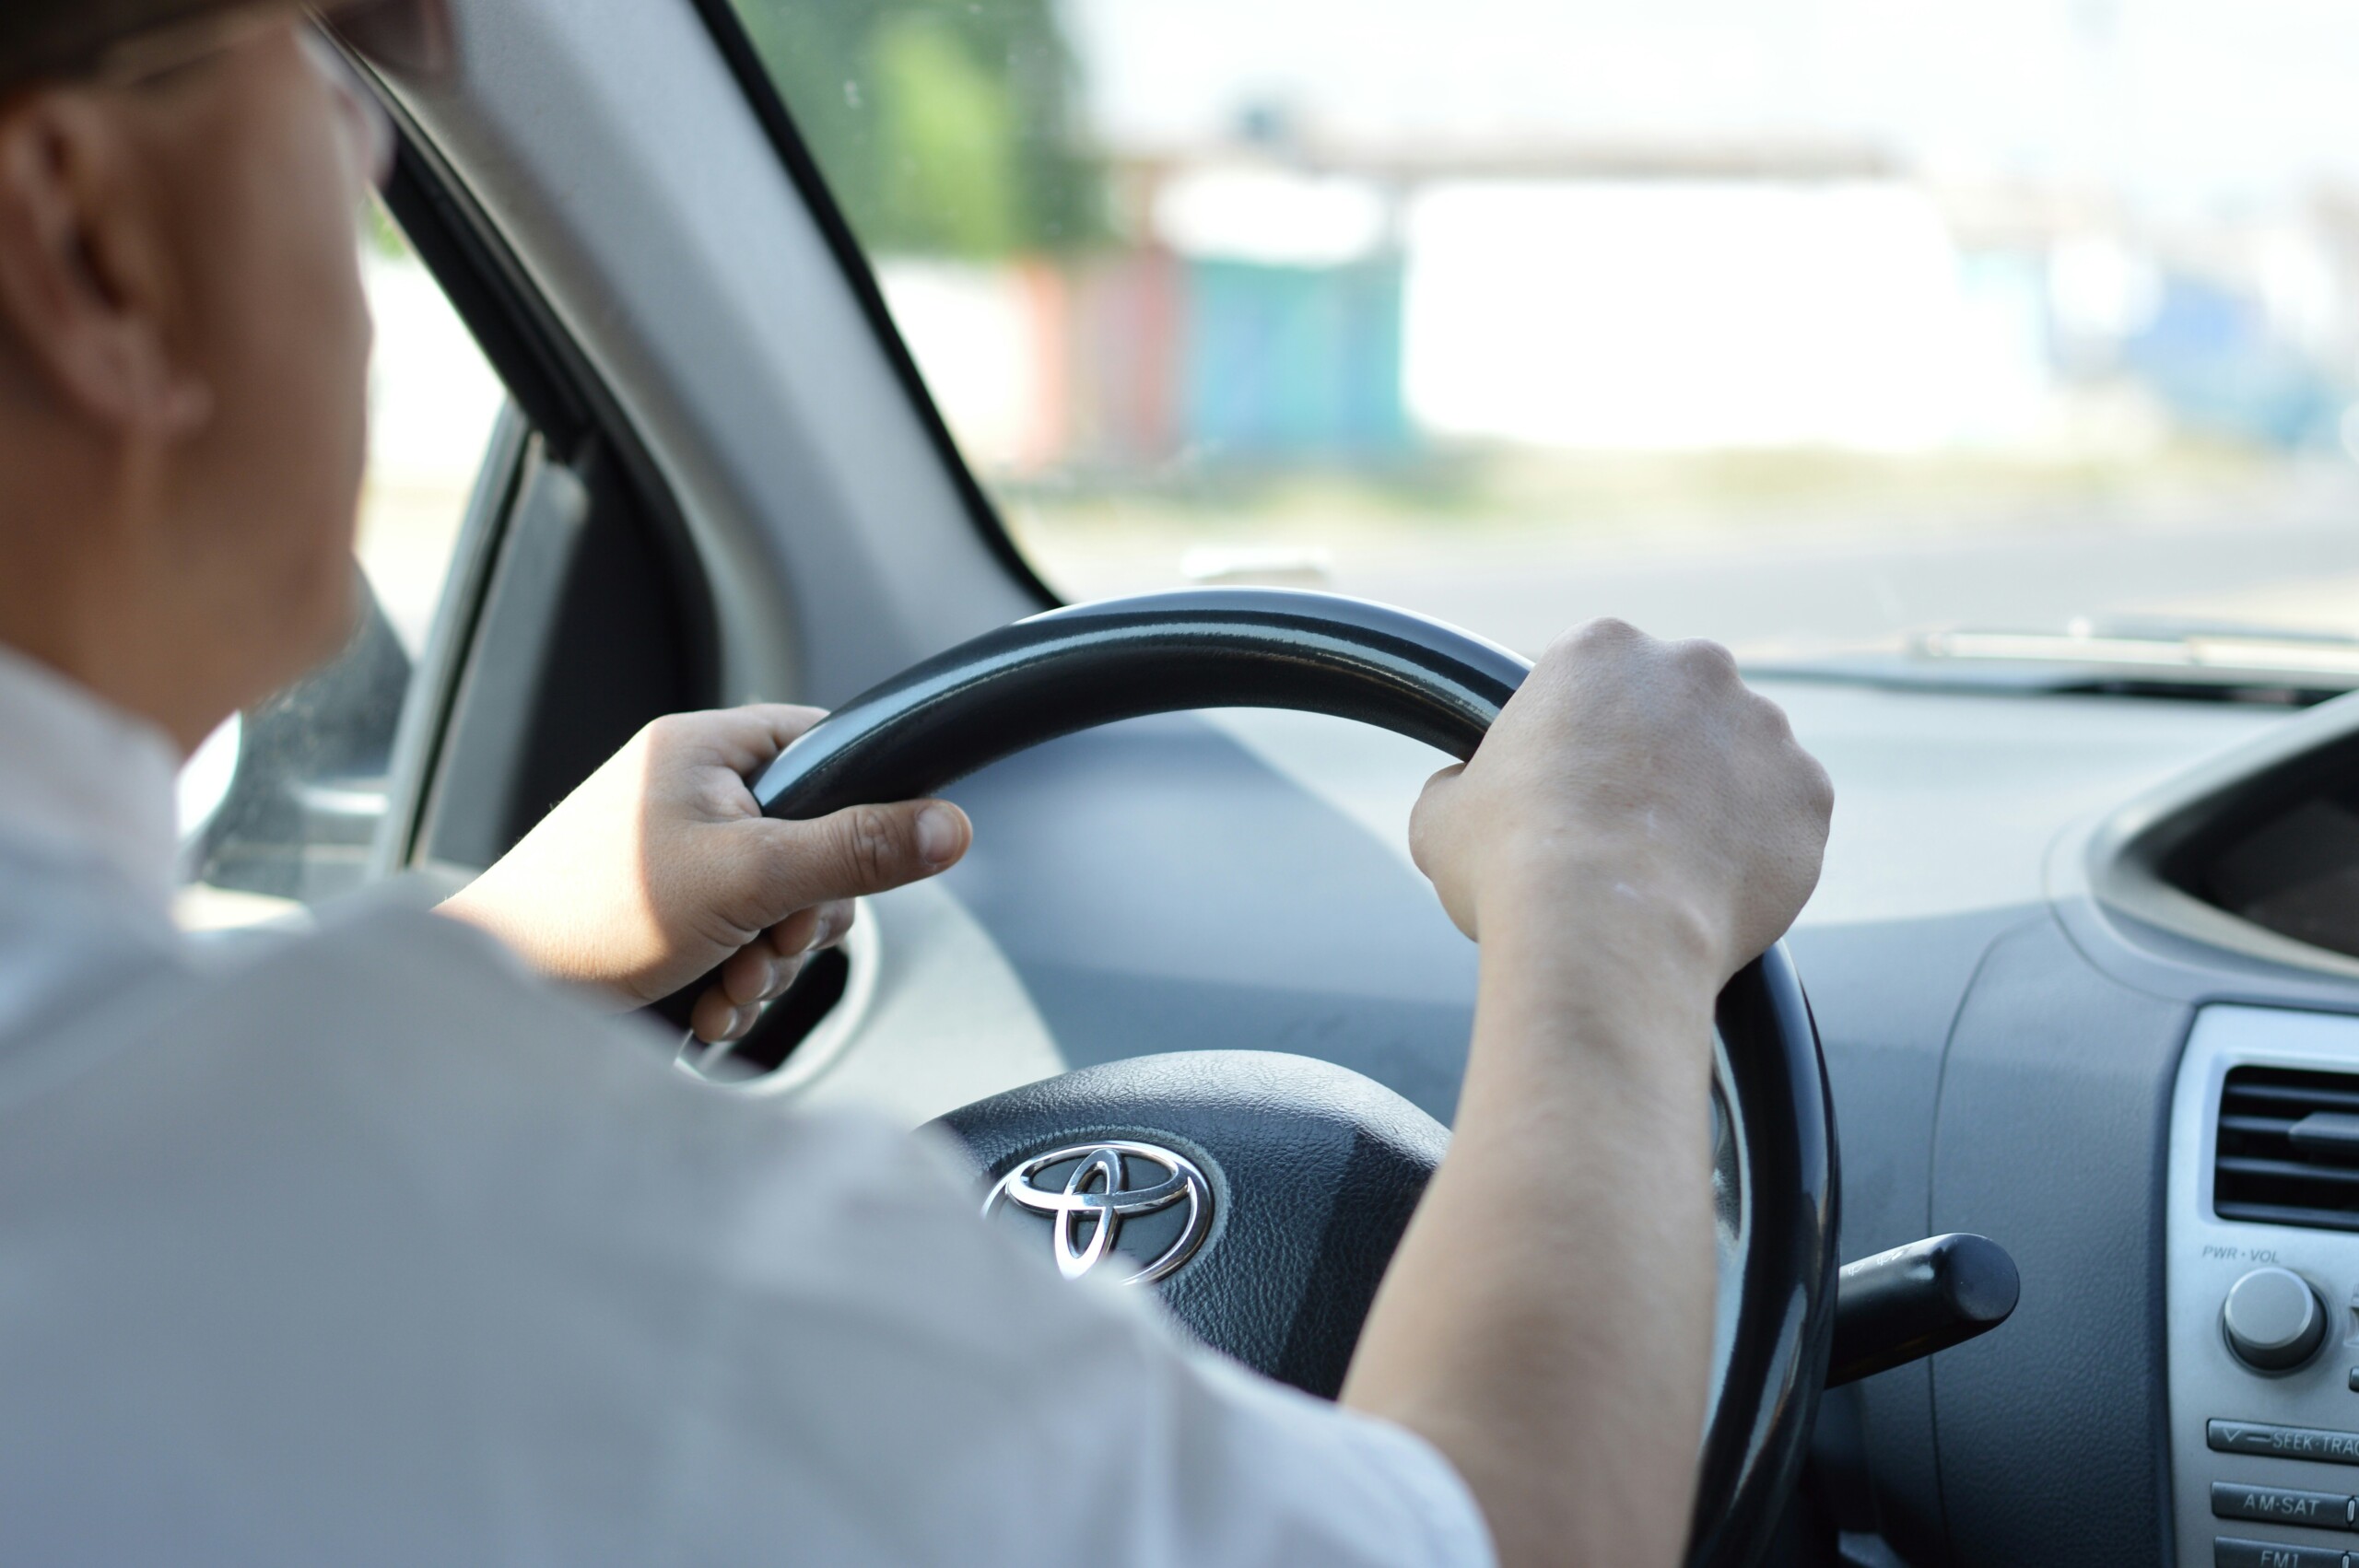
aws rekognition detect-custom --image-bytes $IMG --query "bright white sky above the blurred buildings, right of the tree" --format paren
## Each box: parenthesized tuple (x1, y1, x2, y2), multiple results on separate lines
(1066, 0, 2359, 207)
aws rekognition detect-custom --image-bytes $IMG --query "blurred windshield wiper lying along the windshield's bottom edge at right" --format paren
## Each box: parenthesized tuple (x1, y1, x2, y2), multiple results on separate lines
(1748, 620, 2359, 708)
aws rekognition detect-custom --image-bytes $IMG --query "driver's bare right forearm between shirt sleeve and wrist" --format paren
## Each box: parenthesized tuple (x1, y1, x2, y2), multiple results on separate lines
(1344, 882, 1713, 1568)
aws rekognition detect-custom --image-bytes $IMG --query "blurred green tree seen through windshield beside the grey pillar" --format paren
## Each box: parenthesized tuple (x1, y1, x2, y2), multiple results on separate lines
(734, 0, 1107, 260)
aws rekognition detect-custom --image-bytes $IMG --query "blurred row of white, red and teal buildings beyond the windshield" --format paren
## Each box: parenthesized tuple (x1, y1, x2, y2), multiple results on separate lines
(882, 132, 2359, 476)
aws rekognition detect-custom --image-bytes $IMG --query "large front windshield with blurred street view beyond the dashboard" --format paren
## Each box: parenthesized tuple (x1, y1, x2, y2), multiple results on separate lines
(736, 0, 2359, 658)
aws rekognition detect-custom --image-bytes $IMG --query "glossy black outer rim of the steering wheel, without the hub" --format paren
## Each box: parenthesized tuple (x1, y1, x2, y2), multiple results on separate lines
(753, 590, 1837, 1568)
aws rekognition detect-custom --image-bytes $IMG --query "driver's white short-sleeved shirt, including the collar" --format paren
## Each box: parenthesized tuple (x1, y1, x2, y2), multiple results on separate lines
(0, 658, 1491, 1568)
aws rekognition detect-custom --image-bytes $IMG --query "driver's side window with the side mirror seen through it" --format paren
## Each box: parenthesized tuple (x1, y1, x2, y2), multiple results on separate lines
(180, 207, 507, 929)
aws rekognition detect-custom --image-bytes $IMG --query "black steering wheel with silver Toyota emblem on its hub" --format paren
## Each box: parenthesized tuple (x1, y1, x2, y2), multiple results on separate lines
(755, 590, 1836, 1568)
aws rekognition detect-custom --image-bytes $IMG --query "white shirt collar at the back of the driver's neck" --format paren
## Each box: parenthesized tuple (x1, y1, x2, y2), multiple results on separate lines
(0, 644, 180, 915)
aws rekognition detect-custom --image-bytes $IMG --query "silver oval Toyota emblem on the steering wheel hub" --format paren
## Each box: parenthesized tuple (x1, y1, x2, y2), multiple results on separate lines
(984, 1139, 1213, 1285)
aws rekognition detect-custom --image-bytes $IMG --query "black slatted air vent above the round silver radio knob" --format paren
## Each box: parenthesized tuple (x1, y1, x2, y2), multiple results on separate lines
(2212, 1068, 2359, 1231)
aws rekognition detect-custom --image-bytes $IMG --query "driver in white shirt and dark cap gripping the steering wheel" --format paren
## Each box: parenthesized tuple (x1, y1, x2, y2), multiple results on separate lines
(0, 0, 1831, 1568)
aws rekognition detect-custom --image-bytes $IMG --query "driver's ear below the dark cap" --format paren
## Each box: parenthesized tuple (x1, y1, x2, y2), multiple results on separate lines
(0, 88, 212, 441)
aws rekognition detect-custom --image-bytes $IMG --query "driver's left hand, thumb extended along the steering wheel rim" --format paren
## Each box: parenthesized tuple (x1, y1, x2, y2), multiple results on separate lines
(441, 705, 974, 1040)
